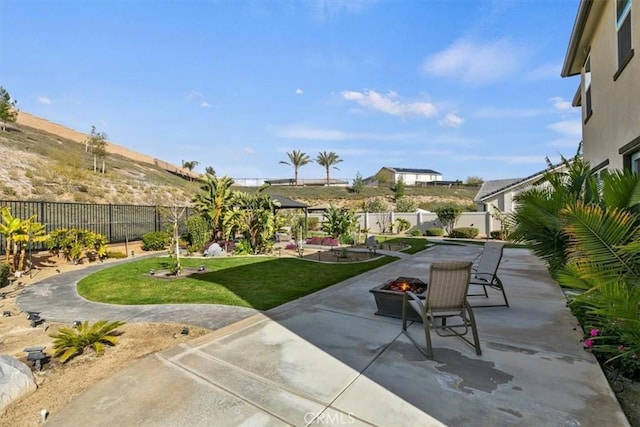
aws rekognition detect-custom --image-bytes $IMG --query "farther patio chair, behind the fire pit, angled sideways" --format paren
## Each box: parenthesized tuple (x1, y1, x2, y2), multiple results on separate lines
(468, 242, 509, 307)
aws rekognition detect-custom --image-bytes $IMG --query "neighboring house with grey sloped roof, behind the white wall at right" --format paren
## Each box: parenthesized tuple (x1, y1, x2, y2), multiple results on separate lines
(473, 163, 566, 213)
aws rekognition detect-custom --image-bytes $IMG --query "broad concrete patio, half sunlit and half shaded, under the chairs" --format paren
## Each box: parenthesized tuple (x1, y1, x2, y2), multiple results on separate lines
(19, 245, 628, 426)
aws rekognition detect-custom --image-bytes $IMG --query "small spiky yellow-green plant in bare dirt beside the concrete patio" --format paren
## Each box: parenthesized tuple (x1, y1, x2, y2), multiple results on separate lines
(50, 320, 125, 363)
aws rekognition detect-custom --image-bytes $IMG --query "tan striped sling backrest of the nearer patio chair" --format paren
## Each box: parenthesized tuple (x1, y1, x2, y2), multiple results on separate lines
(426, 261, 472, 313)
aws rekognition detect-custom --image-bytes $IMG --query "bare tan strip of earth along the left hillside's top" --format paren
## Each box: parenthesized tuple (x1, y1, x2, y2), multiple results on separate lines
(17, 111, 200, 179)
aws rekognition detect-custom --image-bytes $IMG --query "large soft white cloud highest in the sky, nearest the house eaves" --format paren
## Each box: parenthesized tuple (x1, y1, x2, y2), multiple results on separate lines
(422, 39, 523, 85)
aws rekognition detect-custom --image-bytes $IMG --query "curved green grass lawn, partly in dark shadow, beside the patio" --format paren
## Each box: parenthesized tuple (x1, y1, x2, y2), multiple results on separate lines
(78, 257, 396, 310)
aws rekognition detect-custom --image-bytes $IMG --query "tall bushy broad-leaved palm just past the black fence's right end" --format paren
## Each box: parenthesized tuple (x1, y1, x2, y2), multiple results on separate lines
(192, 173, 234, 241)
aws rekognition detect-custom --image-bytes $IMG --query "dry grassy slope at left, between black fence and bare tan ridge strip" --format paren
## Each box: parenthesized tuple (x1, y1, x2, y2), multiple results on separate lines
(0, 125, 197, 205)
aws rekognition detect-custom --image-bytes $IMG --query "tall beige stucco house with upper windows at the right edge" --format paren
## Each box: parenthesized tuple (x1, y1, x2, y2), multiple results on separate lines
(562, 0, 640, 173)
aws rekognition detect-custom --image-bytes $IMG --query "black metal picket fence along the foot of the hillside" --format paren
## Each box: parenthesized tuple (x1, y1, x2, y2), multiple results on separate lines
(0, 200, 193, 253)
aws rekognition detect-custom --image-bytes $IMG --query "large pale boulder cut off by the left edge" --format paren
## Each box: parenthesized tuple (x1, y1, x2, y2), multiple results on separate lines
(0, 355, 37, 415)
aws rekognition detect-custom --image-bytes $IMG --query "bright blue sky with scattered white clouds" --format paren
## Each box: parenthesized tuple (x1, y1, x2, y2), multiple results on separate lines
(0, 0, 581, 180)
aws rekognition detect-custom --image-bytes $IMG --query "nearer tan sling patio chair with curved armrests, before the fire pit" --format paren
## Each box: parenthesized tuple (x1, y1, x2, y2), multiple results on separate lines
(402, 261, 482, 359)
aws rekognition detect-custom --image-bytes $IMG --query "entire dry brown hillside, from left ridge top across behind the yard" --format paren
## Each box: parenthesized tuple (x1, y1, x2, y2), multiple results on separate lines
(0, 113, 477, 210)
